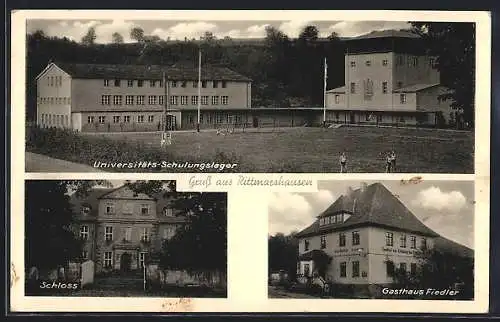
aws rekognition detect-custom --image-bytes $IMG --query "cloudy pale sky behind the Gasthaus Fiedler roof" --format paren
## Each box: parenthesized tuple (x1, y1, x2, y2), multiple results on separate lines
(269, 180, 474, 248)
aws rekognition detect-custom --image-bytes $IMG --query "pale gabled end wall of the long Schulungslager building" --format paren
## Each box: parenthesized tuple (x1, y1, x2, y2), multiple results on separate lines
(37, 65, 72, 128)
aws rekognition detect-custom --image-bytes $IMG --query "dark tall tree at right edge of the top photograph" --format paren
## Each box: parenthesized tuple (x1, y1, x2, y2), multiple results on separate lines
(411, 22, 476, 126)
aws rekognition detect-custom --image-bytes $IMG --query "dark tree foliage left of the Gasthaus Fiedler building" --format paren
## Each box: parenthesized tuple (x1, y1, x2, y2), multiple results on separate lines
(268, 233, 299, 280)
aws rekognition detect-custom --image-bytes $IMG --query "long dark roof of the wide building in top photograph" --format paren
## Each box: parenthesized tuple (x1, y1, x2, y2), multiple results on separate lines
(42, 62, 251, 82)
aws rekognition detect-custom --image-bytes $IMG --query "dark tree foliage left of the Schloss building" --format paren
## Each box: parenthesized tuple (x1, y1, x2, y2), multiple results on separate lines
(25, 180, 111, 269)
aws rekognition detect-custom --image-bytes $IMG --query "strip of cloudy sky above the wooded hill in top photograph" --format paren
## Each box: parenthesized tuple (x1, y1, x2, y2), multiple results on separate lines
(27, 19, 410, 43)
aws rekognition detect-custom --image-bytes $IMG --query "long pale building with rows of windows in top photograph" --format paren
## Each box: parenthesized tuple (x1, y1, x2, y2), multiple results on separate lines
(36, 62, 251, 132)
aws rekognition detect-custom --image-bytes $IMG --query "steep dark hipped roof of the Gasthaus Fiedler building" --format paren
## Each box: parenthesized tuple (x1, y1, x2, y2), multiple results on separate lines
(297, 183, 439, 237)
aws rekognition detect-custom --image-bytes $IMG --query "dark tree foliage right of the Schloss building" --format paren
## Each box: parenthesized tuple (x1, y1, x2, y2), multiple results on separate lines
(129, 181, 227, 272)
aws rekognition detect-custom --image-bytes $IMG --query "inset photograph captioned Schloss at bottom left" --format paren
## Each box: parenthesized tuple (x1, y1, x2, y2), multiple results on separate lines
(25, 180, 227, 298)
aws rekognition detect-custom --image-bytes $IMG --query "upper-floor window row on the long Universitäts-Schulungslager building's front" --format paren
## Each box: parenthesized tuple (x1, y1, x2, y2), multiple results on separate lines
(101, 95, 229, 105)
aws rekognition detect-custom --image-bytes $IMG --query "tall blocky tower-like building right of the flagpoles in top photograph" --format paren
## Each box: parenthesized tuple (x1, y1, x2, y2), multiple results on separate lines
(326, 30, 453, 125)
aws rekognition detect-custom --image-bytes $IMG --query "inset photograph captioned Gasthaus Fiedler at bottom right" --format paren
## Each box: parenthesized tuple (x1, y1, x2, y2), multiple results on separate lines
(268, 180, 475, 300)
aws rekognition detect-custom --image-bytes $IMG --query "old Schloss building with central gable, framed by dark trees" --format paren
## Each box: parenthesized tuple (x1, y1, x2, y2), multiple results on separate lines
(71, 185, 186, 273)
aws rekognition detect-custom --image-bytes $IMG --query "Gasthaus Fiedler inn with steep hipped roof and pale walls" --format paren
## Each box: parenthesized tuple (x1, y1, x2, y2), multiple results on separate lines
(297, 183, 441, 285)
